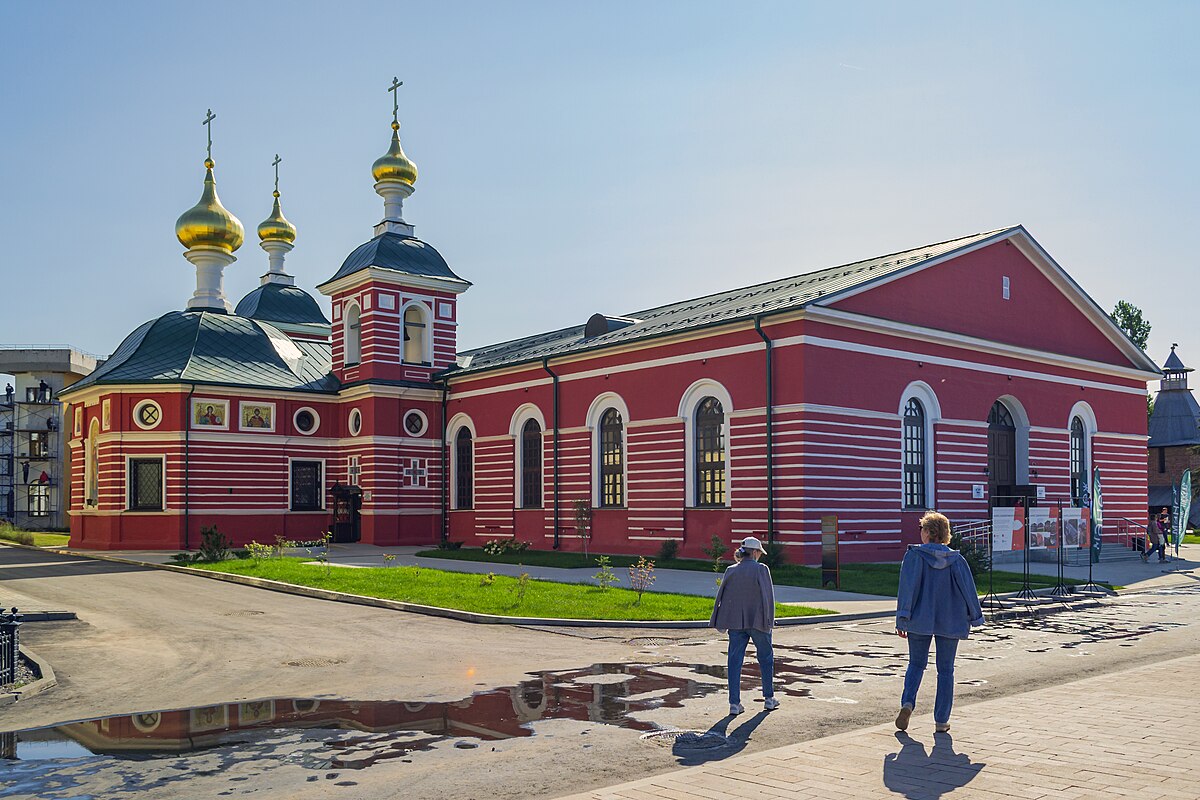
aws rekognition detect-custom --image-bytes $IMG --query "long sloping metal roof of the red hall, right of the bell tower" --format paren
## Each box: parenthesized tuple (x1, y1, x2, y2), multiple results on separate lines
(458, 228, 1016, 372)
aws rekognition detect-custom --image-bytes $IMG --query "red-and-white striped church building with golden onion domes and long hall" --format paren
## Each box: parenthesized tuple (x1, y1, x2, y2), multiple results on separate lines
(61, 97, 1160, 564)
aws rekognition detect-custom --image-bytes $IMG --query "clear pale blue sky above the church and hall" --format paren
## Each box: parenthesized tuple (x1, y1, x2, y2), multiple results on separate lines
(0, 1, 1200, 381)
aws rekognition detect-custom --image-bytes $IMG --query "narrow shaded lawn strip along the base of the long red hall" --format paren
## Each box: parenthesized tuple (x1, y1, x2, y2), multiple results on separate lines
(418, 548, 1099, 597)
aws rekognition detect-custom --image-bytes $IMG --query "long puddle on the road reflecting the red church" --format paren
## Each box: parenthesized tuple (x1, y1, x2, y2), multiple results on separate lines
(5, 664, 720, 768)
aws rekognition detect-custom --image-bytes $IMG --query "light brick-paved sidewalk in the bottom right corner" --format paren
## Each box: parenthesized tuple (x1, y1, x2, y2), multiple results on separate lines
(568, 656, 1200, 800)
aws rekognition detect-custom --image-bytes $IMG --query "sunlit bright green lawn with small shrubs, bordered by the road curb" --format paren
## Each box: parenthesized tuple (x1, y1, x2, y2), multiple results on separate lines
(188, 558, 832, 620)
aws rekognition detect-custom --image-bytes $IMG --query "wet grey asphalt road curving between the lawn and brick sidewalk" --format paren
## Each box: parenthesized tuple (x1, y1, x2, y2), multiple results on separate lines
(0, 547, 1200, 800)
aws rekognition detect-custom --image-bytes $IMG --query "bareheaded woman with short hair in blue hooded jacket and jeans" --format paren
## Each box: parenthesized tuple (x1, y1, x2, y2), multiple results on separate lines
(896, 511, 983, 733)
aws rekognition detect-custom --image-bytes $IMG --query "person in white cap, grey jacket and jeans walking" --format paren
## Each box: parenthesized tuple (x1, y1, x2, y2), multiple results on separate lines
(708, 536, 779, 715)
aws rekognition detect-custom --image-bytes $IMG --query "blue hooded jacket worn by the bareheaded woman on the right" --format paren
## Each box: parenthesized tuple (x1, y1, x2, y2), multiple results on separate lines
(896, 543, 983, 639)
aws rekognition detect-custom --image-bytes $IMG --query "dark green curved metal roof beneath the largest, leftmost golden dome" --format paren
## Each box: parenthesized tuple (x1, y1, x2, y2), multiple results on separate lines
(61, 311, 337, 395)
